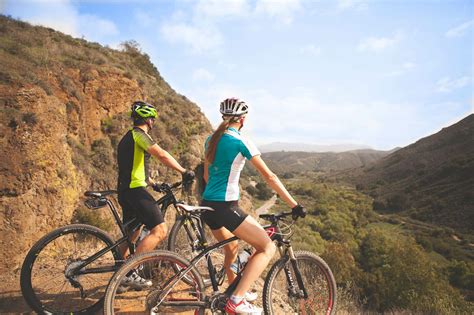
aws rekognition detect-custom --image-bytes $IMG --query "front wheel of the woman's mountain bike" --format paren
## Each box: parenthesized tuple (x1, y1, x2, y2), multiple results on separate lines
(263, 251, 337, 315)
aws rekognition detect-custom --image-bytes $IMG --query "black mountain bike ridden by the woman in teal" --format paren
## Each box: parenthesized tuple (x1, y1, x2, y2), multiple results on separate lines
(104, 207, 336, 315)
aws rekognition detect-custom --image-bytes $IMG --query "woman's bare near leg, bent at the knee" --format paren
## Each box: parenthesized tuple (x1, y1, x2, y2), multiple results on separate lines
(232, 216, 276, 297)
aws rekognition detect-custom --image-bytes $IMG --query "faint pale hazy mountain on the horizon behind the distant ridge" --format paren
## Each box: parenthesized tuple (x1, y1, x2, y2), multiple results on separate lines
(258, 142, 371, 152)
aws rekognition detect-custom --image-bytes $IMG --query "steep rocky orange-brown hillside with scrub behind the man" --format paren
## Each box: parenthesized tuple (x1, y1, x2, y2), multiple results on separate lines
(0, 16, 211, 275)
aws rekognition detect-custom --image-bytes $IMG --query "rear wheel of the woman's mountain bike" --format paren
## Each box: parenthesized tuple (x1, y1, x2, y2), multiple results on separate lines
(104, 250, 206, 315)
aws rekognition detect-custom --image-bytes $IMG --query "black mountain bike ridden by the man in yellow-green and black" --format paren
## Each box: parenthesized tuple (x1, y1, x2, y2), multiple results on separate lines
(20, 182, 186, 314)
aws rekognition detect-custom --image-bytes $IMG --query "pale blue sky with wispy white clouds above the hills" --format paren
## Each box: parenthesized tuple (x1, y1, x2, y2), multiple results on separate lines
(0, 0, 474, 149)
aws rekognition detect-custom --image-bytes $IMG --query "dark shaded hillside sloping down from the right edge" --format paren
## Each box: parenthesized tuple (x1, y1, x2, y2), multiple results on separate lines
(350, 114, 474, 233)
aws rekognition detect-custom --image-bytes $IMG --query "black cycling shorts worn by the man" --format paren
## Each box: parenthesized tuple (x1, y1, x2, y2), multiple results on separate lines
(118, 187, 164, 230)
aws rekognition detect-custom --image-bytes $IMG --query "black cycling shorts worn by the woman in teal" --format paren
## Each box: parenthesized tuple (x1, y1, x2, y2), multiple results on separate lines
(201, 200, 248, 232)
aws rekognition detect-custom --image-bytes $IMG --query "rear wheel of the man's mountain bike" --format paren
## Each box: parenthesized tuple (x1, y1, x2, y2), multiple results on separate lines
(20, 224, 121, 314)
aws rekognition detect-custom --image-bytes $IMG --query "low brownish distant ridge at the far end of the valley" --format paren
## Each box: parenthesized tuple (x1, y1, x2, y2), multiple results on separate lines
(262, 150, 389, 174)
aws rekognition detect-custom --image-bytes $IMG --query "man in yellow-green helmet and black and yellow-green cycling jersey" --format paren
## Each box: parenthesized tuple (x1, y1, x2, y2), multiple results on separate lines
(117, 101, 194, 289)
